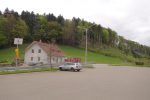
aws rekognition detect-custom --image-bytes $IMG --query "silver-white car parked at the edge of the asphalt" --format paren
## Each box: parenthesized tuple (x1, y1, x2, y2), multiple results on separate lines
(59, 62, 82, 71)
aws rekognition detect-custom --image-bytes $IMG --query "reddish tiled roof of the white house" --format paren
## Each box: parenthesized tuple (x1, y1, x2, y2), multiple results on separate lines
(25, 41, 65, 57)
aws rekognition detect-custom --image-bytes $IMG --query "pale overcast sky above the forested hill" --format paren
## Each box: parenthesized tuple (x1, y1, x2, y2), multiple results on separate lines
(0, 0, 150, 46)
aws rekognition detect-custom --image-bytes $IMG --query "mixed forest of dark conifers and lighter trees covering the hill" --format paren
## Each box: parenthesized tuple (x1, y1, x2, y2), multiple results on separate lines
(0, 8, 150, 58)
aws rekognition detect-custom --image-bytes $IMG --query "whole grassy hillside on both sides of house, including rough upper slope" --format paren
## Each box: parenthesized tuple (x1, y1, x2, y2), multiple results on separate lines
(0, 44, 149, 65)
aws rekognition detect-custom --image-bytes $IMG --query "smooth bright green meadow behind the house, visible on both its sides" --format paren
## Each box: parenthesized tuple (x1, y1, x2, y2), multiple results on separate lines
(0, 44, 123, 64)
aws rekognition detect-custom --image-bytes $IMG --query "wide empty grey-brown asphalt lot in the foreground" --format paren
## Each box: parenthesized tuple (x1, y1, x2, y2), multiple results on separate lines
(0, 65, 150, 100)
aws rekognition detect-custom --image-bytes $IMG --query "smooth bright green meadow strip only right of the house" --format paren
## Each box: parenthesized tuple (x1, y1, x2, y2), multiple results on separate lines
(60, 45, 127, 64)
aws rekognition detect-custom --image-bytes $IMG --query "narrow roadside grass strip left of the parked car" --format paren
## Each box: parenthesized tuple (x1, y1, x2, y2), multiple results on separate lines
(0, 68, 58, 75)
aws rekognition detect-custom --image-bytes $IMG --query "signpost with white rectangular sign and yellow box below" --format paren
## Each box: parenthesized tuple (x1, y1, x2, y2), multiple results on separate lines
(14, 38, 23, 67)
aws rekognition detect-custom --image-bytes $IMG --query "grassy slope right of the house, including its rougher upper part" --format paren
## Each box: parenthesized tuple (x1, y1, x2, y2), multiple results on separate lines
(59, 45, 150, 66)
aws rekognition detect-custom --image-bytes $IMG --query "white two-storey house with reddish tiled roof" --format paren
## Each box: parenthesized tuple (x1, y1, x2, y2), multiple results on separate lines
(24, 41, 65, 65)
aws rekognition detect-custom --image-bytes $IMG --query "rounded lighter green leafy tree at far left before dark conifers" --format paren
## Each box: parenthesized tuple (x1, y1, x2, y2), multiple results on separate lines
(0, 16, 27, 46)
